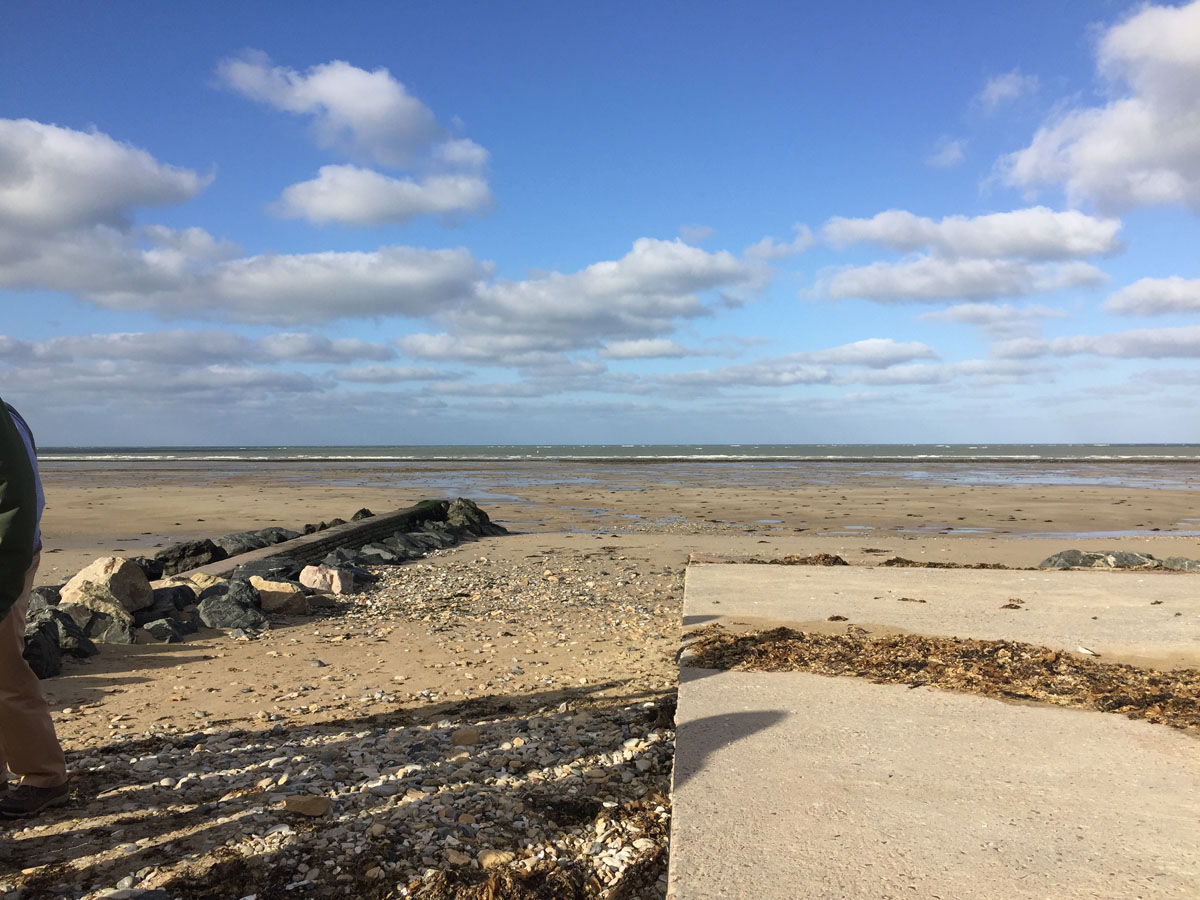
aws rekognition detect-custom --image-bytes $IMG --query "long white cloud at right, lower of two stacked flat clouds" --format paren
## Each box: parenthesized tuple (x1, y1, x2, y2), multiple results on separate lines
(818, 257, 1106, 304)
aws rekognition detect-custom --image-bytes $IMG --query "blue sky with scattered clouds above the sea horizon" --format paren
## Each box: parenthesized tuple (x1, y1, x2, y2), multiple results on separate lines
(0, 0, 1200, 446)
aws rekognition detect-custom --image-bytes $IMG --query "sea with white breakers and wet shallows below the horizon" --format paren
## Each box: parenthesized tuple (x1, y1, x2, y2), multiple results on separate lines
(38, 444, 1200, 496)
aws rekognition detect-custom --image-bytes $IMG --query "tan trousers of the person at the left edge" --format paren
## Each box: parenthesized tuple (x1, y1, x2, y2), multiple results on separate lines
(0, 553, 67, 787)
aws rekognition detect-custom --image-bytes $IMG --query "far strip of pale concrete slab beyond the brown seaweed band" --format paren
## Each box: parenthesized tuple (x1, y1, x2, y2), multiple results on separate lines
(684, 565, 1200, 667)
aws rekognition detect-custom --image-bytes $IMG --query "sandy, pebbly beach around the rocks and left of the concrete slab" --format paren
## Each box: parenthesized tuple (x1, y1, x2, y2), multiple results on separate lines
(9, 462, 1200, 900)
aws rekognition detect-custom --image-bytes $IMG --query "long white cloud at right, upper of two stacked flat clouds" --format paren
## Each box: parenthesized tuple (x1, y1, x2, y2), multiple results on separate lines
(822, 206, 1121, 260)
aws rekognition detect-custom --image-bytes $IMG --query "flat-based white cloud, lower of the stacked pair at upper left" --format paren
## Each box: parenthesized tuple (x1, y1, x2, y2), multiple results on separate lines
(276, 166, 492, 226)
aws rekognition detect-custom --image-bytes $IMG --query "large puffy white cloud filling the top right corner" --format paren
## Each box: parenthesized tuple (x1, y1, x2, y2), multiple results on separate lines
(1000, 0, 1200, 211)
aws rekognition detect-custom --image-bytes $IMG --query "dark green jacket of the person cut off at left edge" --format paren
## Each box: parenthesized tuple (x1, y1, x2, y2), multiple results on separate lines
(0, 403, 37, 619)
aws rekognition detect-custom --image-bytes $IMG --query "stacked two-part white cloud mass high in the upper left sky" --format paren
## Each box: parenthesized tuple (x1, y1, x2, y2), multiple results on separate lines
(217, 52, 492, 226)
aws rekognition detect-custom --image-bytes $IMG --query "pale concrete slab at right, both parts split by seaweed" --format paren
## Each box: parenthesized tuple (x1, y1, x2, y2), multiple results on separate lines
(670, 565, 1200, 900)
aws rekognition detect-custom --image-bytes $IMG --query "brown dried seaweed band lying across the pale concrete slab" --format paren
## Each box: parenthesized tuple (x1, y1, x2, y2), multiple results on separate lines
(686, 625, 1200, 736)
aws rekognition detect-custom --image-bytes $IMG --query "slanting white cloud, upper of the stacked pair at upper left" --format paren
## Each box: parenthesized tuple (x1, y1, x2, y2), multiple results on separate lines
(217, 52, 443, 168)
